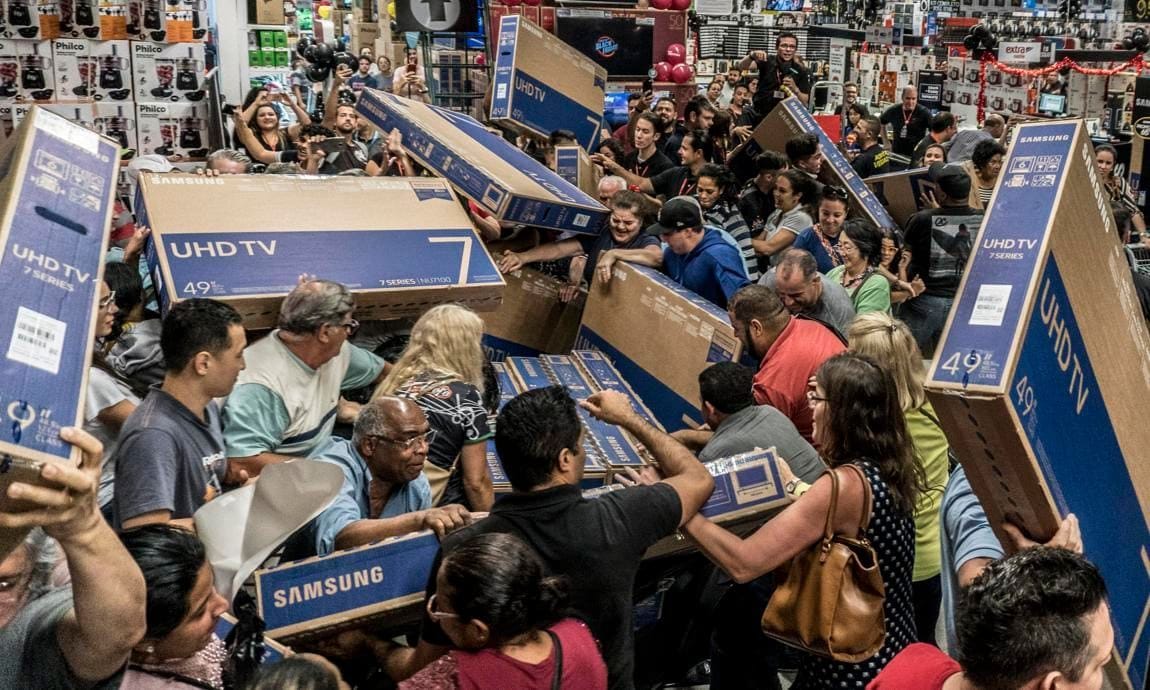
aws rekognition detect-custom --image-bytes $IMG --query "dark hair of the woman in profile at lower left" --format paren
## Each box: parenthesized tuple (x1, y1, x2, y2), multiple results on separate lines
(120, 524, 207, 639)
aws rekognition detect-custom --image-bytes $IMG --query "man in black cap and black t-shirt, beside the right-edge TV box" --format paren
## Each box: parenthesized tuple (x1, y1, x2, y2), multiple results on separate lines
(899, 163, 982, 358)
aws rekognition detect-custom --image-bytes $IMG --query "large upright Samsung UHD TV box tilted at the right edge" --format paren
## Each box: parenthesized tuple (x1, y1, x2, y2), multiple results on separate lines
(927, 120, 1150, 688)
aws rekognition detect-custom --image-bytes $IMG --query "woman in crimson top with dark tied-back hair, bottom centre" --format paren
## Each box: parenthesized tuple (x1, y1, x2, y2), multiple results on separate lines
(399, 534, 607, 690)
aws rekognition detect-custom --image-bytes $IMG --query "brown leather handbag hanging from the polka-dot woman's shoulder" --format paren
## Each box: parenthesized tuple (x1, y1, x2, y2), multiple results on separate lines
(762, 465, 887, 664)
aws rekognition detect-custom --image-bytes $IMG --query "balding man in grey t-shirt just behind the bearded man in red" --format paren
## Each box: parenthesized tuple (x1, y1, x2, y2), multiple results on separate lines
(759, 250, 854, 337)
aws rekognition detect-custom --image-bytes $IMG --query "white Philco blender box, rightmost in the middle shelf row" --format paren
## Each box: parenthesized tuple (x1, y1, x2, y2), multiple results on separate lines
(132, 40, 206, 102)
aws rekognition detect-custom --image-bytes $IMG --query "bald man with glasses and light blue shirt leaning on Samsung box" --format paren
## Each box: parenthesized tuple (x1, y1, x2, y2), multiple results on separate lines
(284, 397, 472, 560)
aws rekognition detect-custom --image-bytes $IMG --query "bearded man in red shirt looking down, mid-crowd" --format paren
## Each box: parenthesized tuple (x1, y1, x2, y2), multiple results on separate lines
(727, 285, 846, 443)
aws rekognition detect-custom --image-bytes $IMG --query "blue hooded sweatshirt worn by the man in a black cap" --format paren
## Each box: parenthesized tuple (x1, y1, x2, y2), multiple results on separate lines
(662, 228, 750, 309)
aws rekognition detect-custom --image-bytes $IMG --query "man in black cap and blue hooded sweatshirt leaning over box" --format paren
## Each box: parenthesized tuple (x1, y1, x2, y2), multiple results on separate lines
(646, 197, 751, 309)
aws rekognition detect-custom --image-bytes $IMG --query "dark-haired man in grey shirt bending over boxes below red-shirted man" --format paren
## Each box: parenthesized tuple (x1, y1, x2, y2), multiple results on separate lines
(673, 362, 827, 484)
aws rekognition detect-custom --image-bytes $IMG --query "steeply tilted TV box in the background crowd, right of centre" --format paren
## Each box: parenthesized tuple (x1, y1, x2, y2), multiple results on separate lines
(742, 97, 895, 228)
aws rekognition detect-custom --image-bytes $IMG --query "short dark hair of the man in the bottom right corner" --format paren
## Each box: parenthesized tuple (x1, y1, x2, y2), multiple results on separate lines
(955, 546, 1106, 690)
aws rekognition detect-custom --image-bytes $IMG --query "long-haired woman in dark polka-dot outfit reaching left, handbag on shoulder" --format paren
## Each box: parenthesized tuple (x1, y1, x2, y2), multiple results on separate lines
(683, 352, 925, 690)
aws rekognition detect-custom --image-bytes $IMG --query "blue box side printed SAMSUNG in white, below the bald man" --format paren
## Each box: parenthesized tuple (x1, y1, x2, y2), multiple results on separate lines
(255, 532, 439, 641)
